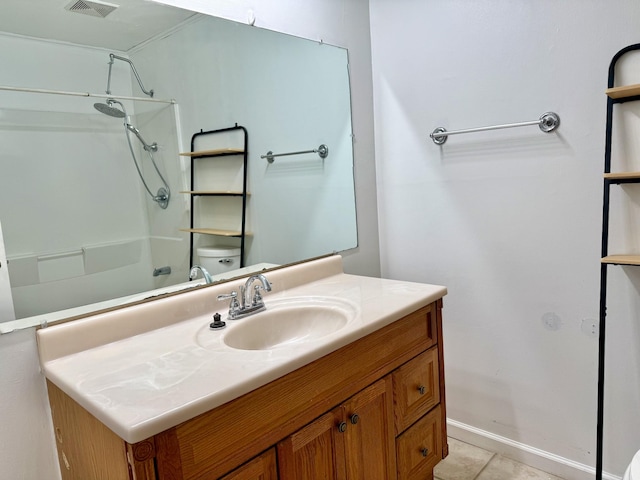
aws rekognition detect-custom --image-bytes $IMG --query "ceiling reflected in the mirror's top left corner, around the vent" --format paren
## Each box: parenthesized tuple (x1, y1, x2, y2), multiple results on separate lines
(0, 0, 194, 52)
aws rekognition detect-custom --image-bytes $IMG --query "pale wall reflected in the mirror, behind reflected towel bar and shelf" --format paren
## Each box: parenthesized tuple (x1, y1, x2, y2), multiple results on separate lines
(131, 17, 356, 265)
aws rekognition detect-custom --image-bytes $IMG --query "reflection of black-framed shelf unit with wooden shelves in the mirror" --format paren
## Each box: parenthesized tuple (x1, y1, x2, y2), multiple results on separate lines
(180, 124, 250, 268)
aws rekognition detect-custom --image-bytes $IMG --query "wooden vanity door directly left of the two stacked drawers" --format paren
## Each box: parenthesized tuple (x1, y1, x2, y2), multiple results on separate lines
(342, 376, 396, 480)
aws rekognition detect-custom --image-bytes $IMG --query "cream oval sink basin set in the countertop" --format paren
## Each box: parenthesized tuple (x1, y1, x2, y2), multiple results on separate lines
(223, 297, 357, 350)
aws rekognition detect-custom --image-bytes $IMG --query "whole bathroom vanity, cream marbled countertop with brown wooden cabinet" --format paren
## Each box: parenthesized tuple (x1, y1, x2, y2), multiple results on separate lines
(38, 256, 447, 480)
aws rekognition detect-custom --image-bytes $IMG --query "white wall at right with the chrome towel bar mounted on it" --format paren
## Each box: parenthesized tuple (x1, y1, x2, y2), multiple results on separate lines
(370, 0, 640, 478)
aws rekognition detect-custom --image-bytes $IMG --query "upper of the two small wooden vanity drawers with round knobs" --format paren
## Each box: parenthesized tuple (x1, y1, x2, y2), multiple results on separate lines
(393, 347, 440, 435)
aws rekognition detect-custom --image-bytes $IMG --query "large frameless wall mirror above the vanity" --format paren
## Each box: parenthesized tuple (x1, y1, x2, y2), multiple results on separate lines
(0, 0, 357, 324)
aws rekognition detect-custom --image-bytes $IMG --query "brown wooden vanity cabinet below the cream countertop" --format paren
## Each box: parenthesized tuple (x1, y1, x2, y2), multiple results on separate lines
(48, 300, 448, 480)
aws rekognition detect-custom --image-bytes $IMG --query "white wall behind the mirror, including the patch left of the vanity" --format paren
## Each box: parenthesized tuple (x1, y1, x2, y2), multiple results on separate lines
(0, 0, 379, 480)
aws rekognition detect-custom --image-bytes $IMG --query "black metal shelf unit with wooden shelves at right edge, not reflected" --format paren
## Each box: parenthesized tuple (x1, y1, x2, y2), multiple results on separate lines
(596, 44, 640, 480)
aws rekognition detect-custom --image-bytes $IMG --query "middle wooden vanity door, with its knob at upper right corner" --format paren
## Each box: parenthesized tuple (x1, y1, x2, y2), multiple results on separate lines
(278, 409, 346, 480)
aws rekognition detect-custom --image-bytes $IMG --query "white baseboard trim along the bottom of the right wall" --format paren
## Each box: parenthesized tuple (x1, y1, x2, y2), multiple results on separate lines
(447, 419, 622, 480)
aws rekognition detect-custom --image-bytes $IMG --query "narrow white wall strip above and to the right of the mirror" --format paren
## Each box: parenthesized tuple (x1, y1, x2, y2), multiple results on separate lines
(151, 0, 380, 276)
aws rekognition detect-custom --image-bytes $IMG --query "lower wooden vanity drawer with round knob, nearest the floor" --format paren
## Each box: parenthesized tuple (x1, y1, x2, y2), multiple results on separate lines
(396, 406, 442, 480)
